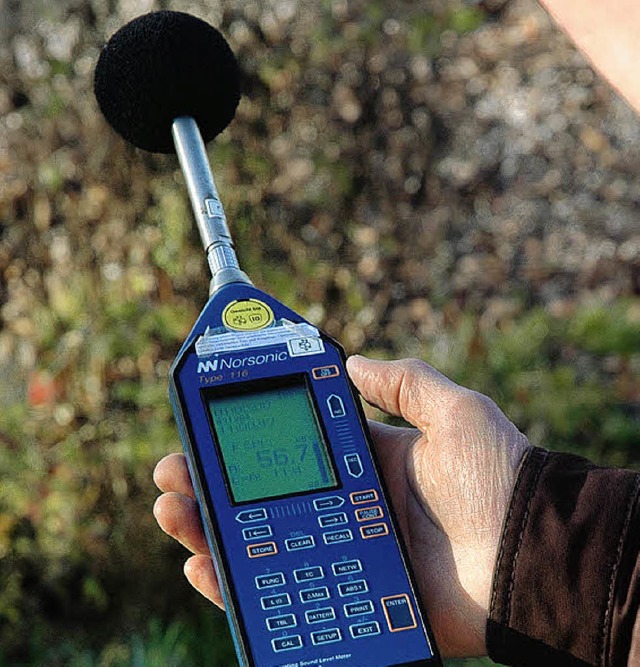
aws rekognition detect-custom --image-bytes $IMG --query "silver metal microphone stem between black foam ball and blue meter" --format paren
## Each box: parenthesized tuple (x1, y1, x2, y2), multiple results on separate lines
(171, 116, 251, 294)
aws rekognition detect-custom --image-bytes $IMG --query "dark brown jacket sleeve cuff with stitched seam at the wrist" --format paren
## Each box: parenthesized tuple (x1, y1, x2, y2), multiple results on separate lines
(487, 448, 640, 667)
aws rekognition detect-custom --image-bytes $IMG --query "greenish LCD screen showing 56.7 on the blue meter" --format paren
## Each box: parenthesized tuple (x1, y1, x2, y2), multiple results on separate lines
(205, 376, 337, 503)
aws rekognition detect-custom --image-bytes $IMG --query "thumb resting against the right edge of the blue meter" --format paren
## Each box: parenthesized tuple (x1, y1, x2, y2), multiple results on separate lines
(347, 355, 462, 431)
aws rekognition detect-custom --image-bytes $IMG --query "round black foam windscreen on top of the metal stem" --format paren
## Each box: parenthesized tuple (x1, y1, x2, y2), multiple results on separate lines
(94, 11, 240, 153)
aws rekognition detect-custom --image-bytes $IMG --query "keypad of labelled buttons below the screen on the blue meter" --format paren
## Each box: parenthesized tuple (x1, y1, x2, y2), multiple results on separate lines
(242, 489, 417, 653)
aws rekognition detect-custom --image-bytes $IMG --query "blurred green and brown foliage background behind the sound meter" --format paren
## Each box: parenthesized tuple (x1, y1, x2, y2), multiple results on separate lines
(0, 0, 640, 667)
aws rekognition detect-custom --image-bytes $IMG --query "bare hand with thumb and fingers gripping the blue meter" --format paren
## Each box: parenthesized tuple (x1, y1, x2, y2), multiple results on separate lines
(154, 357, 529, 656)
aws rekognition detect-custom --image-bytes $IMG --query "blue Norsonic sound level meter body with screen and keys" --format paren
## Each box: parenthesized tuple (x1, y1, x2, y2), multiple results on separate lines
(170, 283, 441, 667)
